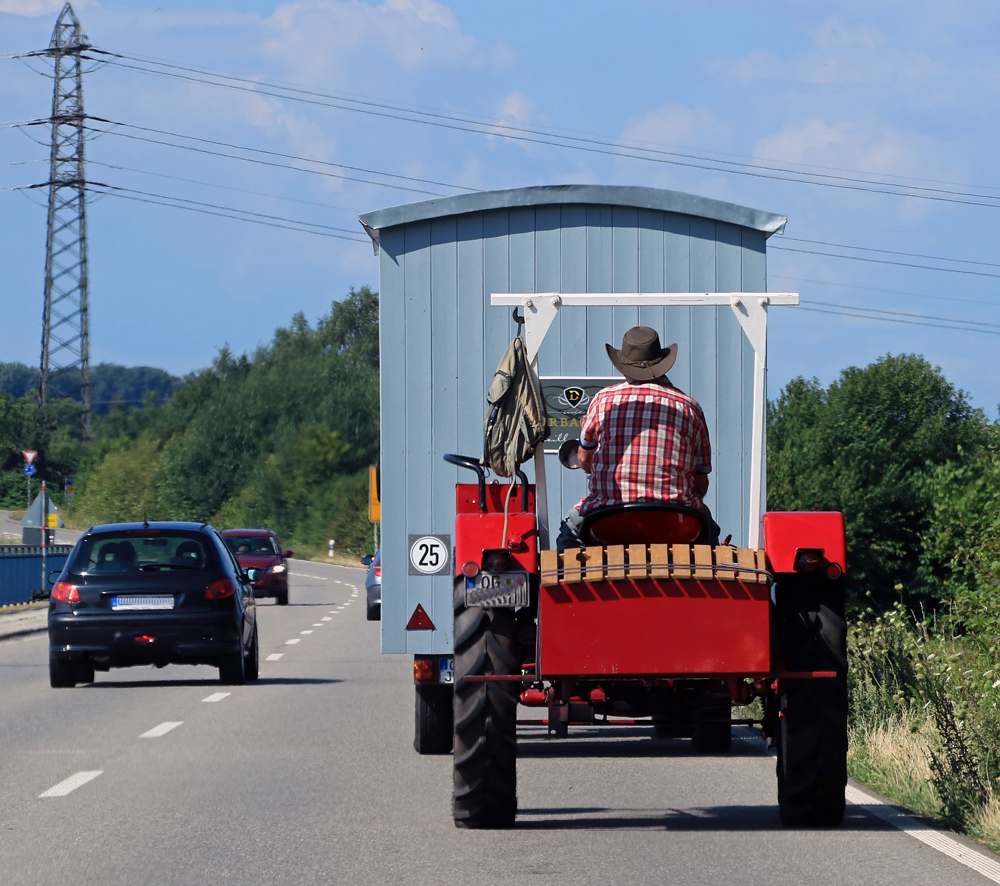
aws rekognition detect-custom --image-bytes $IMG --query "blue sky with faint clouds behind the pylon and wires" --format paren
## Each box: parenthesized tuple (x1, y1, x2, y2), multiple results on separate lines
(0, 0, 1000, 417)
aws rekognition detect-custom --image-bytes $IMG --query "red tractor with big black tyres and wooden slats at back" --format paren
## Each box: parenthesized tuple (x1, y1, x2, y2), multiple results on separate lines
(445, 294, 847, 828)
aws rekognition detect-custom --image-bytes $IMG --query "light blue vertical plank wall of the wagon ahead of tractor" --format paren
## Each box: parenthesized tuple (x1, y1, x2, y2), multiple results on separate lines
(379, 203, 766, 653)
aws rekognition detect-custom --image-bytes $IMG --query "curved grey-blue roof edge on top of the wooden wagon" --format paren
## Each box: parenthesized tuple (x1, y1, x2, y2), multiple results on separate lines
(359, 185, 788, 236)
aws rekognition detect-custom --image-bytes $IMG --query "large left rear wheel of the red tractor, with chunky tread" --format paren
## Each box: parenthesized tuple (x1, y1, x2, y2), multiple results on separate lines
(453, 576, 521, 829)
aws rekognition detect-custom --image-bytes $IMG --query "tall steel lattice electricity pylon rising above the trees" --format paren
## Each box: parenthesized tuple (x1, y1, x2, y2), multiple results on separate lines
(38, 3, 90, 439)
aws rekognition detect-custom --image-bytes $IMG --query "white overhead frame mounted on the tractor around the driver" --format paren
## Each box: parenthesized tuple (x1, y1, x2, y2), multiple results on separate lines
(490, 292, 799, 549)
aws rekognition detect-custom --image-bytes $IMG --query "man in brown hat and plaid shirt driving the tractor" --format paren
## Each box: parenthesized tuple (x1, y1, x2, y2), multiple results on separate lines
(556, 326, 719, 551)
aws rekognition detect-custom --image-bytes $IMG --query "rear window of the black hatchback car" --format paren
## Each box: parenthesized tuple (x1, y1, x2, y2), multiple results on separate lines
(70, 530, 218, 575)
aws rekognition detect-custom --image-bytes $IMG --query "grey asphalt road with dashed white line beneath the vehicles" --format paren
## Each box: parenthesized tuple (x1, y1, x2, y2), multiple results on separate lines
(0, 562, 990, 886)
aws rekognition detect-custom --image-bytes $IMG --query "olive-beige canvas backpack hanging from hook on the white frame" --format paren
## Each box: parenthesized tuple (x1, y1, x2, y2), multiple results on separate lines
(482, 336, 549, 477)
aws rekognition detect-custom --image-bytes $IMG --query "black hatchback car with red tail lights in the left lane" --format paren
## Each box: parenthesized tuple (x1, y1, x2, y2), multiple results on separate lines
(49, 523, 258, 687)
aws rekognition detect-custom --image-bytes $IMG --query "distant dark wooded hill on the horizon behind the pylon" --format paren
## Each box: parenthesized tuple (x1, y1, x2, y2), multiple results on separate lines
(0, 363, 180, 415)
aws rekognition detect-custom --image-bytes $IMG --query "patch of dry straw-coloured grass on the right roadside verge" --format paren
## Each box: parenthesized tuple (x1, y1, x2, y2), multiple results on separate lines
(847, 716, 941, 817)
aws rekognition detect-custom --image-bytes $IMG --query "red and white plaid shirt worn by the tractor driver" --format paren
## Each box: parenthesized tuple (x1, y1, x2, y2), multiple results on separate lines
(580, 381, 712, 514)
